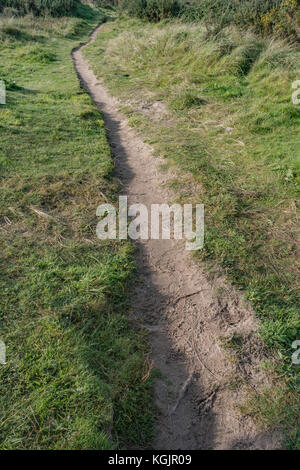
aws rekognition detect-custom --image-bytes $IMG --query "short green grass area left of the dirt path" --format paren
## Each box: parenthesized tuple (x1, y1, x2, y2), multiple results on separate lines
(0, 5, 153, 449)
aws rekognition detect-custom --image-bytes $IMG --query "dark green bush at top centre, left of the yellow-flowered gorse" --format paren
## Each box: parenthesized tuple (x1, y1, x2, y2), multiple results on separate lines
(120, 0, 182, 23)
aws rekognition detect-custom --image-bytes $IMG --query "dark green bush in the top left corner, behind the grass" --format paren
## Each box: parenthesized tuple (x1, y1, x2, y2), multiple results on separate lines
(0, 0, 77, 16)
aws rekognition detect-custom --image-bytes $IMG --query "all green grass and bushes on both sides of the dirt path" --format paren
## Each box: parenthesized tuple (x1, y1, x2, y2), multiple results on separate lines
(0, 0, 300, 449)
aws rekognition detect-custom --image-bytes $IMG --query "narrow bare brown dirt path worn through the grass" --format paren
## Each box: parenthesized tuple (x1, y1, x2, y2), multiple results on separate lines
(72, 23, 278, 450)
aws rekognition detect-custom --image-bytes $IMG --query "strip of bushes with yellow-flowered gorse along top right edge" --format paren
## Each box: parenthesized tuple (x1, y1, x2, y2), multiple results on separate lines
(118, 0, 300, 40)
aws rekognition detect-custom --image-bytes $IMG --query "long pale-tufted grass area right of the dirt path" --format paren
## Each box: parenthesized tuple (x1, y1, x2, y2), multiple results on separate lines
(85, 17, 300, 448)
